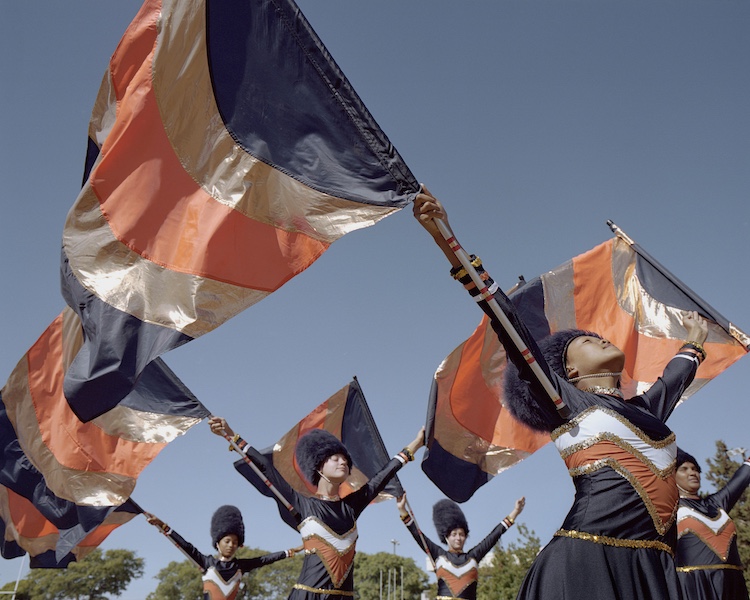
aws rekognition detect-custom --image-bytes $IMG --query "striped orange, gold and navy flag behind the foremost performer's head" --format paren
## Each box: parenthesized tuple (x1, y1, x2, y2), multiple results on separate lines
(422, 230, 750, 502)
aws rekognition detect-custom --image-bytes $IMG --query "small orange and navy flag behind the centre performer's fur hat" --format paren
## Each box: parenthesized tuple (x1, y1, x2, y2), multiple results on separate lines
(234, 378, 404, 530)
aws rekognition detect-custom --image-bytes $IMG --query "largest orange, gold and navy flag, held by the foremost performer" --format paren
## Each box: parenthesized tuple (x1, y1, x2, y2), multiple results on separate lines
(61, 0, 419, 420)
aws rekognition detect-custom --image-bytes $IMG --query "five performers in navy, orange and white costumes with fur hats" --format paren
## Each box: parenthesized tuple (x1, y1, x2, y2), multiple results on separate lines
(142, 189, 750, 600)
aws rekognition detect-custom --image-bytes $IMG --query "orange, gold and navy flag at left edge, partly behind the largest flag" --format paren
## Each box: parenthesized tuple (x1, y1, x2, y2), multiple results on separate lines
(0, 308, 209, 507)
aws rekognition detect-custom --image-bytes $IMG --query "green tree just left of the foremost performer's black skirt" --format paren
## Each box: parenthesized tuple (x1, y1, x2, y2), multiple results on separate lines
(477, 523, 541, 600)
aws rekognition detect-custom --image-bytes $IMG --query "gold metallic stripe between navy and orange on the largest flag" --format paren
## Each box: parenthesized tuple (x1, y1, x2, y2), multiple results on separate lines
(152, 0, 397, 243)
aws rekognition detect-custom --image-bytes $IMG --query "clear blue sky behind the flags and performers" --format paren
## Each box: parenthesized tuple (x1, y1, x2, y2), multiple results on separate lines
(0, 0, 750, 600)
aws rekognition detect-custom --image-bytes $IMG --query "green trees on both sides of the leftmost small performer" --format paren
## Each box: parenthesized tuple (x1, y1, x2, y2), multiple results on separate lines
(147, 548, 302, 600)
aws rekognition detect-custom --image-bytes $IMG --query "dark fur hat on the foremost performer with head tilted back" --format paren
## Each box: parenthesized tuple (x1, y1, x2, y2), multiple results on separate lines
(504, 329, 601, 432)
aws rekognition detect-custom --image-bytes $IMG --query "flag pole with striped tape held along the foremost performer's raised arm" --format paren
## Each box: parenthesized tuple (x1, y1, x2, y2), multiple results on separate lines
(435, 219, 570, 419)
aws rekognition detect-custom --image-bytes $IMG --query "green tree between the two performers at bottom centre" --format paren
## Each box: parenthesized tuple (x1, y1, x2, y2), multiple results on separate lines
(354, 552, 429, 600)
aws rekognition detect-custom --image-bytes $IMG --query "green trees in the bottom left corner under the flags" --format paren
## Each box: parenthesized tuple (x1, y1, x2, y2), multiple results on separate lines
(3, 548, 143, 600)
